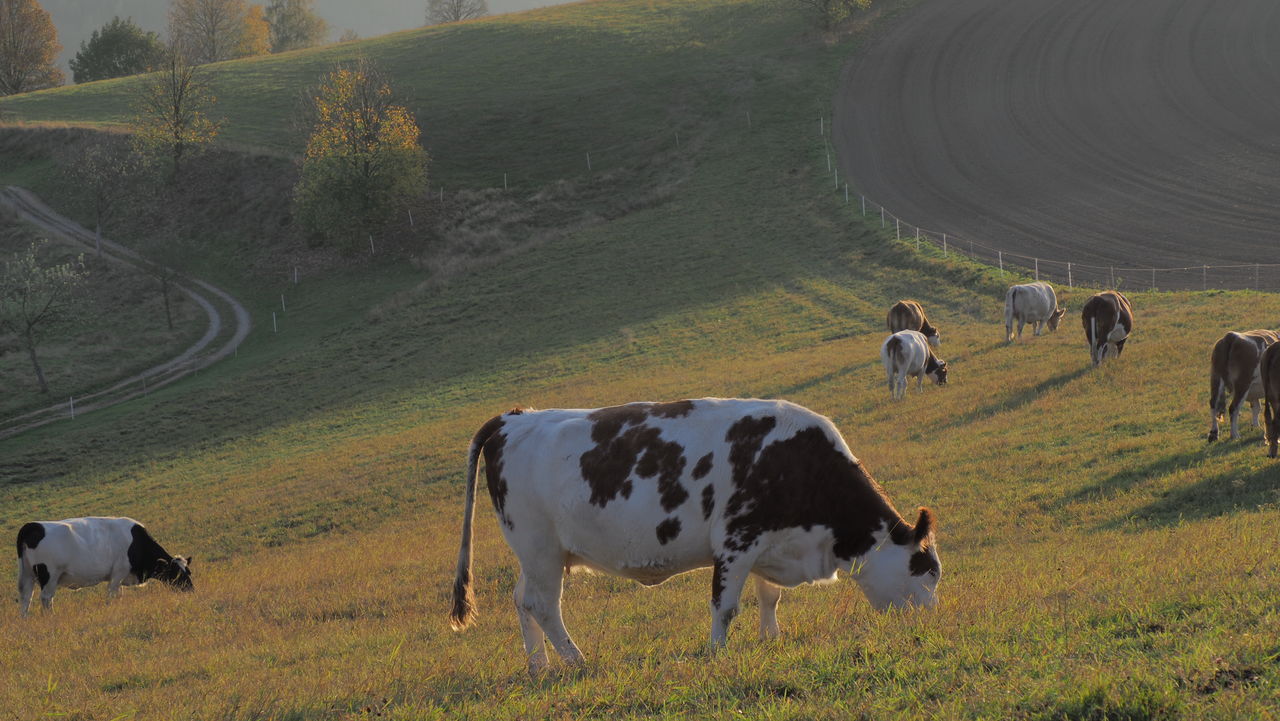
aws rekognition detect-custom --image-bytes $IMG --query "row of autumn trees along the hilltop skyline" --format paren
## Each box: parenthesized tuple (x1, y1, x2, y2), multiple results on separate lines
(0, 0, 489, 96)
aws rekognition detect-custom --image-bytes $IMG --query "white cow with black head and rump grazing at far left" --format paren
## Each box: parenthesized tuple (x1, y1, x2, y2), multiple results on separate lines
(18, 517, 195, 616)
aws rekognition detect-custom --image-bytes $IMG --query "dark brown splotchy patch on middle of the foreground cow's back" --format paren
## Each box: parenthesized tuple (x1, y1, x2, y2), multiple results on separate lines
(579, 401, 692, 512)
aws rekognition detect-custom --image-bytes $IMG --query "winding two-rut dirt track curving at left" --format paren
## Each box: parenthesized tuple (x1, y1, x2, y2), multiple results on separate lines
(0, 186, 252, 438)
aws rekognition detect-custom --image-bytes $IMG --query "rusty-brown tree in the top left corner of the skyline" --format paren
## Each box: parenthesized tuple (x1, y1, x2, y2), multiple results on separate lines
(0, 0, 65, 95)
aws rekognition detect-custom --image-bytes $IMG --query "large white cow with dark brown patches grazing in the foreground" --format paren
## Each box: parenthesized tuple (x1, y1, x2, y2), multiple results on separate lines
(451, 398, 941, 672)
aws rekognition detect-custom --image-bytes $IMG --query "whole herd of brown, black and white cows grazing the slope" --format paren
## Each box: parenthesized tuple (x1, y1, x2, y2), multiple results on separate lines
(17, 271, 1280, 672)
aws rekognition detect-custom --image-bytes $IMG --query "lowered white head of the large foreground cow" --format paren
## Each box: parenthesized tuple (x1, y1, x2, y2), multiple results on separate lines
(854, 507, 942, 611)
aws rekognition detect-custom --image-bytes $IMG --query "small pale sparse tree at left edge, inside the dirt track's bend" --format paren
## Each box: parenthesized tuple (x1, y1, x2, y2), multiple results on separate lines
(0, 241, 86, 393)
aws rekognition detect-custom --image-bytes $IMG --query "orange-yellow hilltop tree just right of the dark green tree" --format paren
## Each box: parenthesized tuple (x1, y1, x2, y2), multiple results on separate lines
(169, 0, 269, 65)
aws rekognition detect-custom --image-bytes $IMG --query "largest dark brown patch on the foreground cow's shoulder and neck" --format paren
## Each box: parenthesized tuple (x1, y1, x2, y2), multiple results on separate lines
(724, 419, 911, 561)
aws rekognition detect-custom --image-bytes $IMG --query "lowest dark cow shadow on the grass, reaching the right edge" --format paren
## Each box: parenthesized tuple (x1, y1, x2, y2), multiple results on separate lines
(1103, 464, 1280, 528)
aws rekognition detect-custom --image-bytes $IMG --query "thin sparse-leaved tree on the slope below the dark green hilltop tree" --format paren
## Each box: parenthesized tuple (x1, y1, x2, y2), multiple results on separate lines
(133, 47, 220, 184)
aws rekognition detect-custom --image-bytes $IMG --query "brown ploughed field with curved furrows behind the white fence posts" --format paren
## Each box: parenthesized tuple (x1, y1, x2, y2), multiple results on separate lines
(833, 0, 1280, 289)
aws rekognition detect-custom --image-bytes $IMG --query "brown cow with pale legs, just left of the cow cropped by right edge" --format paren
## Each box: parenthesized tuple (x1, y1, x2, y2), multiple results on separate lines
(1208, 330, 1280, 443)
